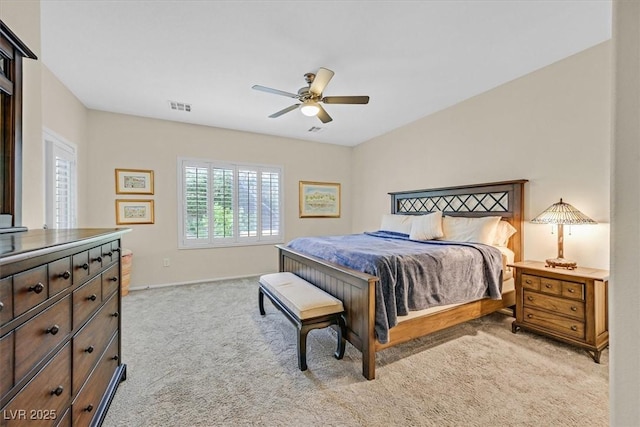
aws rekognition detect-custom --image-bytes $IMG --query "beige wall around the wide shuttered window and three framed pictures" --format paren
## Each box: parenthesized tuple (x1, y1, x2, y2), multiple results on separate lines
(87, 111, 352, 287)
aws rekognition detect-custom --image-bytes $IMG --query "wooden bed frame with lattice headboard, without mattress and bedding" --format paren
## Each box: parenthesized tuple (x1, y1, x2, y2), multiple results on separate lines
(277, 180, 527, 380)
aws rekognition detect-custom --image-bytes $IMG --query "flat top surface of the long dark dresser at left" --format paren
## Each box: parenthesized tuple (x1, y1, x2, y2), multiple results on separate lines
(0, 228, 131, 265)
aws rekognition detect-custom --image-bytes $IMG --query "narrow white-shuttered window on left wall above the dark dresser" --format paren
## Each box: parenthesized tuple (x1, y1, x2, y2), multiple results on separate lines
(44, 132, 77, 228)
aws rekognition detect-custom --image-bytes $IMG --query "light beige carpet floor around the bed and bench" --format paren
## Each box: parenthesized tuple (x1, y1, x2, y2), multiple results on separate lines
(104, 278, 609, 427)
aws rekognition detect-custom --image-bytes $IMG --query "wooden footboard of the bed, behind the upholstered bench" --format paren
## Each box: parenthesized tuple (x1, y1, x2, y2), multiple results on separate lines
(277, 245, 378, 380)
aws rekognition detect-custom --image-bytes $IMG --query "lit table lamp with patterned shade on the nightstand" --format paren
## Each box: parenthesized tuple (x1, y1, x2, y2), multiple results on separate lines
(531, 199, 596, 270)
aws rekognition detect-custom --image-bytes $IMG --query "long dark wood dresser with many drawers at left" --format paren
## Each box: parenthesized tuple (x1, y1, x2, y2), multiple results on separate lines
(0, 229, 129, 426)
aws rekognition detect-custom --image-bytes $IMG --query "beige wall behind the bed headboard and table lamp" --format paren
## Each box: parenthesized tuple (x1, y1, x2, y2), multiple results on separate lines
(352, 42, 611, 268)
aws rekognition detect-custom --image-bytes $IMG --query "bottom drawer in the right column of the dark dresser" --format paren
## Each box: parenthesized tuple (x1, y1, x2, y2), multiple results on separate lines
(71, 334, 120, 426)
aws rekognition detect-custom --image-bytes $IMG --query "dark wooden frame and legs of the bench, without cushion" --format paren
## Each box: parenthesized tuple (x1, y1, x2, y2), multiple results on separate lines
(258, 284, 346, 371)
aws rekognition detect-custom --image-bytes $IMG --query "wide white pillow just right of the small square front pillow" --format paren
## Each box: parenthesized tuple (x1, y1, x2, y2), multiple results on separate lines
(442, 216, 500, 245)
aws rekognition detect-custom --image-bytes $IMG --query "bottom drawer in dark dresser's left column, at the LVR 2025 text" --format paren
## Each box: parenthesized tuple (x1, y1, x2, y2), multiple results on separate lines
(3, 344, 71, 426)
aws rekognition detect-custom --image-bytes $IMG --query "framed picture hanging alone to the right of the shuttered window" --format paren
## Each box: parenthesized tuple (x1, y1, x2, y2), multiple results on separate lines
(300, 181, 340, 218)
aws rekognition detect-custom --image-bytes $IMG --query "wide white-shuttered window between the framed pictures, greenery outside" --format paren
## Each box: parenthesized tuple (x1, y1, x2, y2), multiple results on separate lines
(178, 159, 283, 248)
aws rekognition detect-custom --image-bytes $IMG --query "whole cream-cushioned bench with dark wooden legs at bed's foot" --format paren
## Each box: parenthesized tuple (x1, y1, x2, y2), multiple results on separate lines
(258, 272, 345, 371)
